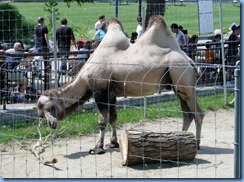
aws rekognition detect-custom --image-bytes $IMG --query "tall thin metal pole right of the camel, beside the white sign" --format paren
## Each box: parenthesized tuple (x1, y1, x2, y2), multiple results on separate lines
(219, 2, 227, 105)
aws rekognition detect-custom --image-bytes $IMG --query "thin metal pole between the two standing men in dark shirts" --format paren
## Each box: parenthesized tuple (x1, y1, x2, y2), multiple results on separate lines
(52, 8, 58, 89)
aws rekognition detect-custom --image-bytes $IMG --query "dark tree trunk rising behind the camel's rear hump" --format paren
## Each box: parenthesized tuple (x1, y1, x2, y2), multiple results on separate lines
(145, 0, 166, 28)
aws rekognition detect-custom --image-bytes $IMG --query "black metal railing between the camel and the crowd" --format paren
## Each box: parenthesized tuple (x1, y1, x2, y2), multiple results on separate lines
(0, 41, 239, 108)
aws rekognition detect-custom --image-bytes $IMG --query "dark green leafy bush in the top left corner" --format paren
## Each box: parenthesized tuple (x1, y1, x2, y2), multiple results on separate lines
(0, 3, 33, 42)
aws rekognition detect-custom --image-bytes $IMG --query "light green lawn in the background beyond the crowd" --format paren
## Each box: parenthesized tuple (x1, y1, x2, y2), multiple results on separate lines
(7, 2, 240, 38)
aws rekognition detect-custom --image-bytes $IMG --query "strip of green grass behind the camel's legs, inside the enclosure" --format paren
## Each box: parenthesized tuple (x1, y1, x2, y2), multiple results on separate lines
(0, 93, 234, 144)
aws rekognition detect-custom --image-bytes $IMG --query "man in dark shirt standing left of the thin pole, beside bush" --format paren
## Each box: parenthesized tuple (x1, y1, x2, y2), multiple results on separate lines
(33, 16, 51, 90)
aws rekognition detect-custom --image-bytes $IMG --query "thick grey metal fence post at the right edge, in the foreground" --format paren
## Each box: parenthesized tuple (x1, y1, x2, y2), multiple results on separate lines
(234, 61, 241, 178)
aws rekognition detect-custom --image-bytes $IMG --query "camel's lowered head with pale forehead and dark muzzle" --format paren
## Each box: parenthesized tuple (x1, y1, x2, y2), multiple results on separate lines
(36, 93, 65, 129)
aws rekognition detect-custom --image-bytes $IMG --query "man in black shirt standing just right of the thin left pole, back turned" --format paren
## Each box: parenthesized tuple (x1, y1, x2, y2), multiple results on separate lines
(56, 18, 77, 74)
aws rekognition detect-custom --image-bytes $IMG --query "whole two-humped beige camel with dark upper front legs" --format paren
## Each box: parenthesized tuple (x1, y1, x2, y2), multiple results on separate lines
(37, 15, 204, 154)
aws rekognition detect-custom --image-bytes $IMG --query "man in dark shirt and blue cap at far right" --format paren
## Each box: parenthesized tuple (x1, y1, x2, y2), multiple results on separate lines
(226, 24, 240, 81)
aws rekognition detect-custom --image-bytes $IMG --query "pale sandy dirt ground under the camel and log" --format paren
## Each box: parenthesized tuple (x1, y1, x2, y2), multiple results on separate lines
(0, 109, 234, 178)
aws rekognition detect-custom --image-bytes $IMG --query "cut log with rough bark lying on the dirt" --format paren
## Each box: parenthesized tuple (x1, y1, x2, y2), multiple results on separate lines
(119, 130, 197, 166)
